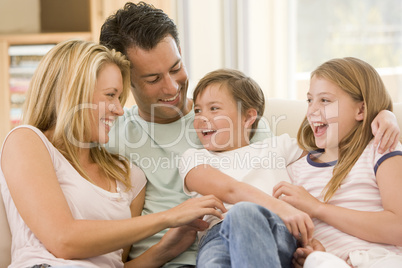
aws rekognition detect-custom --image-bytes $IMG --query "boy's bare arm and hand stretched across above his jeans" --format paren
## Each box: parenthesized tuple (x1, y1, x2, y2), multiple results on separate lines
(185, 165, 314, 244)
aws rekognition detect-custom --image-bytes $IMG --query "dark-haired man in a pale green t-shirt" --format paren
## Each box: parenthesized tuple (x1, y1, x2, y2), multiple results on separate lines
(100, 2, 251, 267)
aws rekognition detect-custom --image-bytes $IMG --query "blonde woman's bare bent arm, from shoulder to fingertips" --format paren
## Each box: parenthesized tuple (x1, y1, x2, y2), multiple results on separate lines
(1, 129, 224, 259)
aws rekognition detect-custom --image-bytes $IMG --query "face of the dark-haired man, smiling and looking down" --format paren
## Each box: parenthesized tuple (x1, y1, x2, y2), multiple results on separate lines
(127, 36, 191, 124)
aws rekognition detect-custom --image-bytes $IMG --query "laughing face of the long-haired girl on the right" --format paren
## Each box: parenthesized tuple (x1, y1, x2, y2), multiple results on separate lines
(307, 76, 363, 157)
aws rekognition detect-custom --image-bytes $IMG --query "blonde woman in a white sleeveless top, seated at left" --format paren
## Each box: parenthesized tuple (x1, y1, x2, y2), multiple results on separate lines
(0, 40, 224, 267)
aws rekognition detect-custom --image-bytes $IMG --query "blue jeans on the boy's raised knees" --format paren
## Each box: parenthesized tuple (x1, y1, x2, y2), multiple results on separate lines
(197, 202, 296, 268)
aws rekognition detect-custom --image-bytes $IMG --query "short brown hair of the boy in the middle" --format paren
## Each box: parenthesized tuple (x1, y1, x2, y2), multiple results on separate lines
(193, 69, 265, 139)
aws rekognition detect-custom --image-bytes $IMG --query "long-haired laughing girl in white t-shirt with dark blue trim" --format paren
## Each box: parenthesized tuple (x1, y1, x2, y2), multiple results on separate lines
(274, 58, 402, 268)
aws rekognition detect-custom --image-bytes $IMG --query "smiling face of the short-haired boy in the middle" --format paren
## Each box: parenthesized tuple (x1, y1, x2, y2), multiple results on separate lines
(194, 84, 251, 151)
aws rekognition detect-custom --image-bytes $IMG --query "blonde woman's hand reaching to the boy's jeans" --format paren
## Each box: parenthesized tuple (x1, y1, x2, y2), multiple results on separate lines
(163, 195, 227, 228)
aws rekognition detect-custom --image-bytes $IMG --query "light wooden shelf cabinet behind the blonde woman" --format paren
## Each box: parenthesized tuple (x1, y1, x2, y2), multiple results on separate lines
(0, 0, 103, 143)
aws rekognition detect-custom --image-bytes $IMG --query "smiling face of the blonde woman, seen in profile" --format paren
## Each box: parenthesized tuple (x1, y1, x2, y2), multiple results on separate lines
(91, 63, 124, 143)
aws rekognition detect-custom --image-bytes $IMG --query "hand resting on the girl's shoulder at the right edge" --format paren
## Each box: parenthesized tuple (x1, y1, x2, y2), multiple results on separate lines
(371, 110, 400, 153)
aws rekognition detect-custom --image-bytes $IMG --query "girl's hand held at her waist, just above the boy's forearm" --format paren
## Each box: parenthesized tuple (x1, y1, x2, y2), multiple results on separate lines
(273, 181, 323, 218)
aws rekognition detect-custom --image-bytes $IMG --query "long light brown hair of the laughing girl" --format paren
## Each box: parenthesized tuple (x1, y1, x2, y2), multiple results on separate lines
(297, 57, 392, 202)
